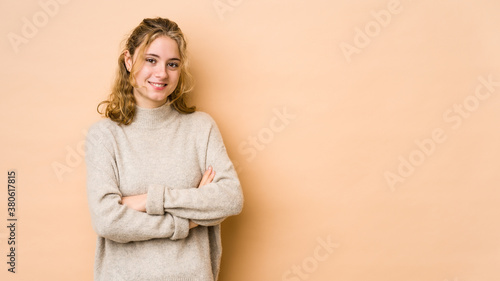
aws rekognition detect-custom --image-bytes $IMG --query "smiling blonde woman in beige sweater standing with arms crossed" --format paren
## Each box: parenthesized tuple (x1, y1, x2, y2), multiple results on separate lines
(85, 18, 243, 281)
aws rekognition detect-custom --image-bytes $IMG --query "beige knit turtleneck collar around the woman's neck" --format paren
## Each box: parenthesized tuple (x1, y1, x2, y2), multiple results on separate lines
(130, 102, 176, 128)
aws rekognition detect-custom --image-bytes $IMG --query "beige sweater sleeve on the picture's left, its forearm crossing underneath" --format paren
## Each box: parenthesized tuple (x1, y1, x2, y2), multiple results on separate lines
(85, 121, 189, 243)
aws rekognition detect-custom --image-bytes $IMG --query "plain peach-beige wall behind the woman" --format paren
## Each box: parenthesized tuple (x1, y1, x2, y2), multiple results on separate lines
(0, 0, 500, 281)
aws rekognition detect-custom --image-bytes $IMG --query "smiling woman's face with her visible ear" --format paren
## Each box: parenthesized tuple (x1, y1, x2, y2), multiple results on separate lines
(125, 36, 181, 108)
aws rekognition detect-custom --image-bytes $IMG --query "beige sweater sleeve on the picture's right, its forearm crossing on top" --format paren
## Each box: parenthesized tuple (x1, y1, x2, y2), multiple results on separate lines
(146, 114, 243, 221)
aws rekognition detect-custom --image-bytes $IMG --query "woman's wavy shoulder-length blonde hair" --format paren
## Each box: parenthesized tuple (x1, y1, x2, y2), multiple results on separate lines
(97, 18, 196, 125)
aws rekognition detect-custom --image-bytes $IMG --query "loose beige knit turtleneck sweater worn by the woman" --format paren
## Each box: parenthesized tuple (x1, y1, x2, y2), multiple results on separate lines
(85, 101, 243, 281)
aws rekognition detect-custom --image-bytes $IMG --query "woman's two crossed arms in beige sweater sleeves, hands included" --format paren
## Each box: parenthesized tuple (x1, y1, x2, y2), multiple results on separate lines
(85, 121, 243, 243)
